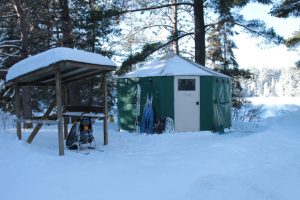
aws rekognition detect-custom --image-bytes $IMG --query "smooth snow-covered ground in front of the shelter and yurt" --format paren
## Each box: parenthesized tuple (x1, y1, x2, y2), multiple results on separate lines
(0, 98, 300, 200)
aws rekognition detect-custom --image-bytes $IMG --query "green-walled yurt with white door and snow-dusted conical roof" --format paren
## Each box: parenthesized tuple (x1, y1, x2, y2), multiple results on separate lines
(117, 54, 231, 132)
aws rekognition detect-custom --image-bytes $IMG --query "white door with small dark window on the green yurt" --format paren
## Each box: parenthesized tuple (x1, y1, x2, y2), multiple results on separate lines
(174, 76, 200, 131)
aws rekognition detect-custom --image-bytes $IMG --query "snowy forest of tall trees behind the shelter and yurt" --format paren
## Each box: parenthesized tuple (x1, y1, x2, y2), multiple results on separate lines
(0, 0, 300, 122)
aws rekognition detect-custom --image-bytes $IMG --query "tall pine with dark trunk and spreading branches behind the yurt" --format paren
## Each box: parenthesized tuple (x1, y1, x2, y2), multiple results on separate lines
(115, 0, 282, 75)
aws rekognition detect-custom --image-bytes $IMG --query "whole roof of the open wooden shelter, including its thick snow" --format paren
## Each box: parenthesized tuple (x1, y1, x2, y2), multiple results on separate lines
(6, 47, 117, 86)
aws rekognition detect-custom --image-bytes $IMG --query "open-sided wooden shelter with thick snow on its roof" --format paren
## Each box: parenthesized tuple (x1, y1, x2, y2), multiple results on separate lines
(6, 47, 117, 155)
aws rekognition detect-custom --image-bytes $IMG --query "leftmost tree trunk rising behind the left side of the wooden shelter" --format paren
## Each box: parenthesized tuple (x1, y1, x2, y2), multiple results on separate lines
(13, 0, 32, 128)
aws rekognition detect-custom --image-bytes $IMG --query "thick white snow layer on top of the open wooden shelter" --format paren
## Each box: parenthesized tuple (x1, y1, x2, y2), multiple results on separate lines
(6, 47, 117, 81)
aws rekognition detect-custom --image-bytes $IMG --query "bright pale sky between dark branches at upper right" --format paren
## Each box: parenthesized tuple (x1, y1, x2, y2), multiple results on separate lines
(235, 1, 300, 68)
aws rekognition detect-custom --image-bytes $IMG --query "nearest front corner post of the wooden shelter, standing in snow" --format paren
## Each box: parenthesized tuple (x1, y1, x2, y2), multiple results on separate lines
(55, 68, 64, 156)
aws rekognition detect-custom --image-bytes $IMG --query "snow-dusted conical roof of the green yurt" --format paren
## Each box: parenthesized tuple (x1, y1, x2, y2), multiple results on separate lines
(121, 54, 230, 78)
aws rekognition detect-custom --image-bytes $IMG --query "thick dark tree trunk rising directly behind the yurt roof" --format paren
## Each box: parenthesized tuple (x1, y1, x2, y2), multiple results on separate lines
(194, 0, 205, 65)
